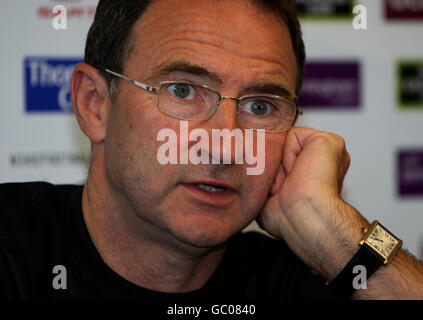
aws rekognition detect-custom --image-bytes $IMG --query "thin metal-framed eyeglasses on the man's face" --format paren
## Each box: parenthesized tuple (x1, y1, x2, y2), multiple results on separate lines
(102, 69, 302, 132)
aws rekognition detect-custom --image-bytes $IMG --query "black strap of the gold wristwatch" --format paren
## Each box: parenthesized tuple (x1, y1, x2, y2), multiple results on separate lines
(329, 242, 385, 299)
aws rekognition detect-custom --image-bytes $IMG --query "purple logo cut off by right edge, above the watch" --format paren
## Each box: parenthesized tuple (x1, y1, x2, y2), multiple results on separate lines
(397, 148, 423, 197)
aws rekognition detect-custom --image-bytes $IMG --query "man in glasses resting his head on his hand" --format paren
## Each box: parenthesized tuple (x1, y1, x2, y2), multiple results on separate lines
(0, 0, 423, 301)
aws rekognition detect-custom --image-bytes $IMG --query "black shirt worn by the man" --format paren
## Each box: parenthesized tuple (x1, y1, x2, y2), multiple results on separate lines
(0, 182, 336, 301)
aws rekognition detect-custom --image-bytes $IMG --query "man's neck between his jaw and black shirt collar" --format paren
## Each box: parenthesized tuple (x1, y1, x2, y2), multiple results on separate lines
(82, 151, 225, 292)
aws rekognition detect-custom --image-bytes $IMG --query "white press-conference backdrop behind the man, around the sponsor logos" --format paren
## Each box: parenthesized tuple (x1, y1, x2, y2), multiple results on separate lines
(0, 0, 423, 258)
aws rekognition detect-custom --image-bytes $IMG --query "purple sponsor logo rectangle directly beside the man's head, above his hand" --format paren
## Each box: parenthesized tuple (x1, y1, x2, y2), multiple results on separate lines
(299, 61, 361, 110)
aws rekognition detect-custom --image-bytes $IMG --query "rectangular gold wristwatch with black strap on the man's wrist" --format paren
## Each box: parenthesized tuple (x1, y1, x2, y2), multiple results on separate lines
(327, 220, 402, 298)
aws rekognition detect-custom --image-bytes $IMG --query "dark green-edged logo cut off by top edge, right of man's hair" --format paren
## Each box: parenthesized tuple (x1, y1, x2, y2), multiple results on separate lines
(297, 0, 356, 19)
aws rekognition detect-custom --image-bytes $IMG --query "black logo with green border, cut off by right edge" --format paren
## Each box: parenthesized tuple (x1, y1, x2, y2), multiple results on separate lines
(397, 59, 423, 109)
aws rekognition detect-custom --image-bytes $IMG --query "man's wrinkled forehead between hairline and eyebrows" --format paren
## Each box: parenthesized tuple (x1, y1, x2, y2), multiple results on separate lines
(125, 0, 296, 90)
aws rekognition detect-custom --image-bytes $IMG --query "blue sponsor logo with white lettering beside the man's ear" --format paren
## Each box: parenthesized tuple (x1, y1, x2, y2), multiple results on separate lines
(24, 57, 82, 112)
